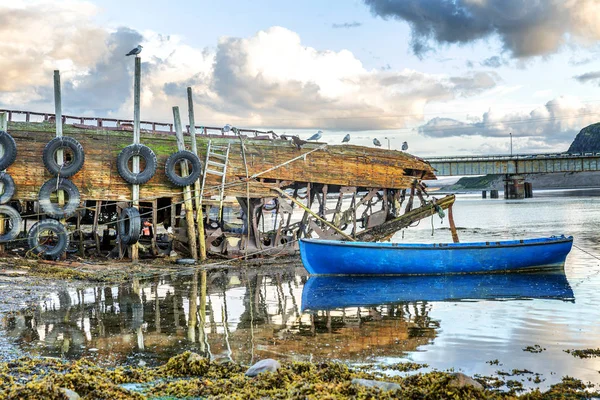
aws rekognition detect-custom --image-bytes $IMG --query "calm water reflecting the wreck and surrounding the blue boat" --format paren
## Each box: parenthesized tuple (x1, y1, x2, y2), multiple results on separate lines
(6, 190, 600, 387)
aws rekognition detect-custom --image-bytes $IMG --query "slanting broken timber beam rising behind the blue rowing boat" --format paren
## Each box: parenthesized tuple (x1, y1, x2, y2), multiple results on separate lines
(356, 195, 455, 242)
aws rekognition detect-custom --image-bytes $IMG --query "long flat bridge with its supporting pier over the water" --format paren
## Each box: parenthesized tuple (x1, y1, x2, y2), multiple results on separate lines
(426, 152, 600, 199)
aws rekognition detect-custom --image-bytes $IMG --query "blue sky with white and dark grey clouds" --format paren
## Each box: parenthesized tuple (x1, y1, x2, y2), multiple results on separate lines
(0, 0, 600, 156)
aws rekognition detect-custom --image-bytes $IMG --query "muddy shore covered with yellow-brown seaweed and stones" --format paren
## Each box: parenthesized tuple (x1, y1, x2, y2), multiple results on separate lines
(0, 259, 600, 399)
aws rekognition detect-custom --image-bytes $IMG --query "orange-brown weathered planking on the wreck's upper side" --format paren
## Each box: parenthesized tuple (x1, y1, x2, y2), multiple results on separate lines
(8, 122, 435, 201)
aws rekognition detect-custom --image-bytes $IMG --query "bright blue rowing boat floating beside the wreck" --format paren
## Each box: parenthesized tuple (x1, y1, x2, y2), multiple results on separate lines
(300, 236, 573, 275)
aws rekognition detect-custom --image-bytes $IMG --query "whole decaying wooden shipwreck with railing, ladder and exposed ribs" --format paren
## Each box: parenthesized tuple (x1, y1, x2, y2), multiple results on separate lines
(0, 110, 457, 258)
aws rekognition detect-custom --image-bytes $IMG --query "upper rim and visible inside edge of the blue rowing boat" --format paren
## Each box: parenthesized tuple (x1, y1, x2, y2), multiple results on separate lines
(300, 235, 573, 250)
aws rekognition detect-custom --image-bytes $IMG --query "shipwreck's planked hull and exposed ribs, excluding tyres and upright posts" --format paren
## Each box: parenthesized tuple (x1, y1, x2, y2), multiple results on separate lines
(0, 112, 453, 257)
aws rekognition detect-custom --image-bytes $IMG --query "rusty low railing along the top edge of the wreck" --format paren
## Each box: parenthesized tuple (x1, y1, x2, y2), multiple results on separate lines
(0, 109, 277, 138)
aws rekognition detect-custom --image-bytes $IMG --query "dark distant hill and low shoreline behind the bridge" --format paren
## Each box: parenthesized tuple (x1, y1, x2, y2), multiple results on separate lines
(445, 122, 600, 190)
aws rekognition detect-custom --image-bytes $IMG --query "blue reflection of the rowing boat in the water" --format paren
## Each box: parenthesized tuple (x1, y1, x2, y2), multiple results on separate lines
(302, 272, 574, 311)
